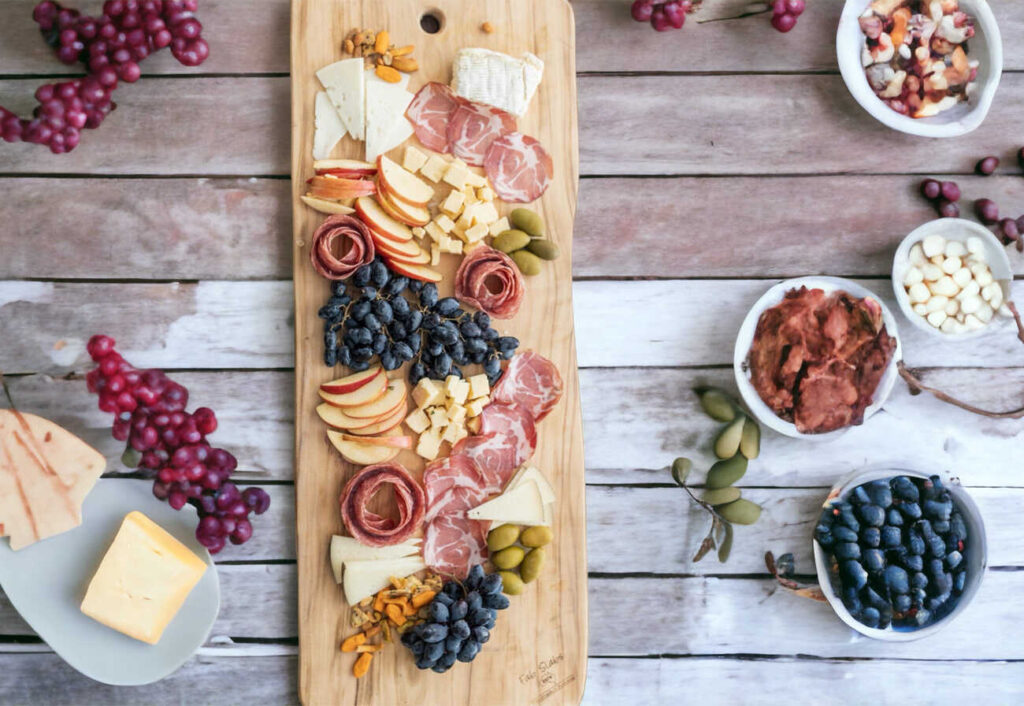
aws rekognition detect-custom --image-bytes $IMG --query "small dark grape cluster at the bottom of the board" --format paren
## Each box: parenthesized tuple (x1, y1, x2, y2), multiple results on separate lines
(401, 565, 509, 673)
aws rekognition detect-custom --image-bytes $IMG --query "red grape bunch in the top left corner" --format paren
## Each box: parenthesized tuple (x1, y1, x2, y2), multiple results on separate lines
(0, 0, 210, 155)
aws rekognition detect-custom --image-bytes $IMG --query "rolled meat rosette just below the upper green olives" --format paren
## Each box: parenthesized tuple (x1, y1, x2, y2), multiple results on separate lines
(455, 245, 526, 319)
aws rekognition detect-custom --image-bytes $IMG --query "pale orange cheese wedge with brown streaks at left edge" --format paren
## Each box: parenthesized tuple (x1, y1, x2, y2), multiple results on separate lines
(0, 410, 106, 551)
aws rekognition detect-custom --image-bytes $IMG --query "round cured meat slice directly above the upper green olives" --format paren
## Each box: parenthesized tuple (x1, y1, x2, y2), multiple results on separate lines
(483, 132, 554, 204)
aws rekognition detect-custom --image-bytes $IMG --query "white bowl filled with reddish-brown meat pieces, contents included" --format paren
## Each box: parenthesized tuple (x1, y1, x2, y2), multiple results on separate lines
(733, 277, 902, 440)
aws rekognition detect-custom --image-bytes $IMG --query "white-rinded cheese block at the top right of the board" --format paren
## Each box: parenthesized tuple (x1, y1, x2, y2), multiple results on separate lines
(452, 48, 544, 116)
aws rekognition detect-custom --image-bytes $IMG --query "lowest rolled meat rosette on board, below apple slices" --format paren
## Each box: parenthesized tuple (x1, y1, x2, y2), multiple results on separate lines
(339, 463, 426, 546)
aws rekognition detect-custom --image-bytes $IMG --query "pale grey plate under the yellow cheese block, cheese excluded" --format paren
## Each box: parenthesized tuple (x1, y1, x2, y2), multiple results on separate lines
(0, 479, 220, 686)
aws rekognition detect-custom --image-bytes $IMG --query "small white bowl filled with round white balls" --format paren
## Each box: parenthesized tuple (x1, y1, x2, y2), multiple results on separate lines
(893, 218, 1013, 339)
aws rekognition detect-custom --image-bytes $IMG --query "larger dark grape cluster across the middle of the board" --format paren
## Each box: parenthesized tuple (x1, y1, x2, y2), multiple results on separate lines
(318, 258, 519, 385)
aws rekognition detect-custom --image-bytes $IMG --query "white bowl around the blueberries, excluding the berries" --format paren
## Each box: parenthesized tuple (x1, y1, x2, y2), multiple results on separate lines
(811, 465, 988, 642)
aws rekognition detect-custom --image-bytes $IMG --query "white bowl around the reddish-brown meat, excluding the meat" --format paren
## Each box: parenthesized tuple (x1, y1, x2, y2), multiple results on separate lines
(732, 277, 903, 441)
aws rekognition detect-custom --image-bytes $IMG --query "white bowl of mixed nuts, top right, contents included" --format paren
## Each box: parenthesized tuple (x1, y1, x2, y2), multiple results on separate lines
(836, 0, 1002, 137)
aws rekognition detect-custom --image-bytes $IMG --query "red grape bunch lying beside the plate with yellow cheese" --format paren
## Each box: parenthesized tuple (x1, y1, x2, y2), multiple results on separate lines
(85, 335, 270, 553)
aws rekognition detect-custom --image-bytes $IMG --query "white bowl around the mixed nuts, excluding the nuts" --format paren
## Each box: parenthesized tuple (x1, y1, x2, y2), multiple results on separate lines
(836, 0, 1002, 137)
